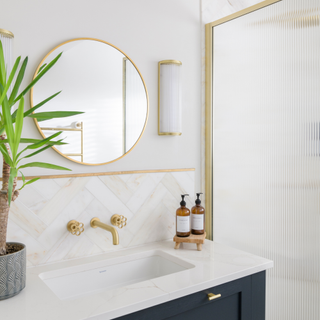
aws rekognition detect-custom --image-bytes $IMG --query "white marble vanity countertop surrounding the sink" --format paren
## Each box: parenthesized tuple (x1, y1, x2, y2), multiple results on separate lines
(0, 240, 273, 320)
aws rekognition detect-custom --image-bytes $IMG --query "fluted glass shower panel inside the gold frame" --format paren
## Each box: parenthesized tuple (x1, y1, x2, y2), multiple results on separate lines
(212, 0, 320, 320)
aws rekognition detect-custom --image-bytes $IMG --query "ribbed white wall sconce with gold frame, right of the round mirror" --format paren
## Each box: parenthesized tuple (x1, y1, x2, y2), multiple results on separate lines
(158, 60, 182, 136)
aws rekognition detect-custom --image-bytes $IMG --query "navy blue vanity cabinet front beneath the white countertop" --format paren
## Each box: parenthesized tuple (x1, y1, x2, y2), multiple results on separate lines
(116, 271, 266, 320)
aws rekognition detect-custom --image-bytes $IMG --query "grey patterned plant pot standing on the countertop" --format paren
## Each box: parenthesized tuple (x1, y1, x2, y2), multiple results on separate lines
(0, 242, 27, 300)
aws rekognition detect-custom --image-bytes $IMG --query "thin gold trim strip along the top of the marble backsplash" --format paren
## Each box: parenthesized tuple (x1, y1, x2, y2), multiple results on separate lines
(0, 168, 196, 181)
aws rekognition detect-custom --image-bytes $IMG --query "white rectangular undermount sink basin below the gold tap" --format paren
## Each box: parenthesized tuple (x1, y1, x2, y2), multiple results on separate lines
(39, 250, 194, 300)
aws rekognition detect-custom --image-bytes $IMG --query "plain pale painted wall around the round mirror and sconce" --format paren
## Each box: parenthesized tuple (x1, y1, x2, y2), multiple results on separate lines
(0, 0, 201, 190)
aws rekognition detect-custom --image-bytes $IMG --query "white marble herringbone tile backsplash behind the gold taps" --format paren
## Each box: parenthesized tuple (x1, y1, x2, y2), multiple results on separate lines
(8, 171, 195, 267)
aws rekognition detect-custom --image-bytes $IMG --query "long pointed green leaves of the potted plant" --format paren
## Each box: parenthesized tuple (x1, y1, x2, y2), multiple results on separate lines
(0, 41, 83, 210)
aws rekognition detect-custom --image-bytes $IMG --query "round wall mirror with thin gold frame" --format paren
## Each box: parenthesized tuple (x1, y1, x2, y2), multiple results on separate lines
(31, 38, 148, 165)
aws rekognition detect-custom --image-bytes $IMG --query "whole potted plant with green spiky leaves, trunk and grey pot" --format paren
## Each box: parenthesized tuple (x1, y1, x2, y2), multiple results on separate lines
(0, 41, 82, 300)
